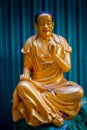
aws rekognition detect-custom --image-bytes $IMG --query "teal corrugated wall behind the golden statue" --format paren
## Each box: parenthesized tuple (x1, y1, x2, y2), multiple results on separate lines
(0, 0, 87, 130)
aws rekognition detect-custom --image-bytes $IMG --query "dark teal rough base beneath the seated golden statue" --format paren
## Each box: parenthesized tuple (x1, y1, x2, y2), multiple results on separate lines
(14, 97, 87, 130)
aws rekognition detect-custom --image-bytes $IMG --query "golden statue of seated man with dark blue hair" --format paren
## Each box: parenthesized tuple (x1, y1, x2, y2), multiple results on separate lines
(12, 11, 84, 127)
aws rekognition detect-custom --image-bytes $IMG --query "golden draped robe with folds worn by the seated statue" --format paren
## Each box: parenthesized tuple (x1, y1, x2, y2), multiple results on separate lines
(12, 34, 84, 126)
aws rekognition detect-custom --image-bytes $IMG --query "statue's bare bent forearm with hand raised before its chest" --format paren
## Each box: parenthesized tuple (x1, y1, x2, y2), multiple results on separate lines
(49, 41, 71, 72)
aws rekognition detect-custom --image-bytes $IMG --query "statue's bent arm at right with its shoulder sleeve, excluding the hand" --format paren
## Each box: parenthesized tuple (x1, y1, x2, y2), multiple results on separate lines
(54, 37, 72, 72)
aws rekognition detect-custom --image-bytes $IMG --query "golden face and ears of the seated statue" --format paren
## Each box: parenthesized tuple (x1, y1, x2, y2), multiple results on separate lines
(36, 13, 54, 37)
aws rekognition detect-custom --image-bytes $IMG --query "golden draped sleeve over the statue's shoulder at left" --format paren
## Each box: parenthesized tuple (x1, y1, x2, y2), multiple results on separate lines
(21, 35, 37, 54)
